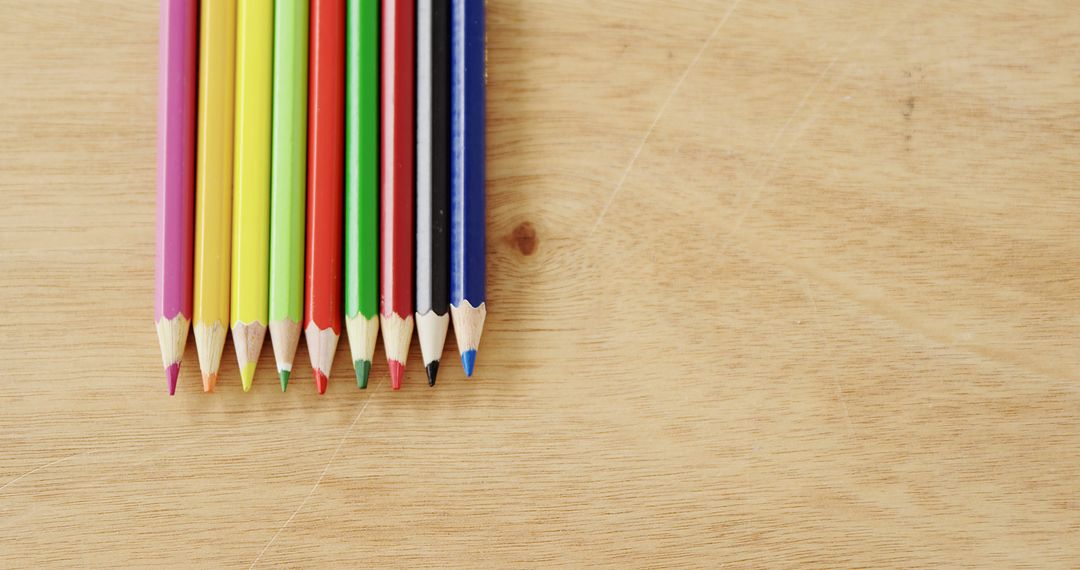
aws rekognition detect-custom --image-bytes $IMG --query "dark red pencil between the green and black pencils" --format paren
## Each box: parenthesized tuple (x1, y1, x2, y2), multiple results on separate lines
(379, 0, 416, 390)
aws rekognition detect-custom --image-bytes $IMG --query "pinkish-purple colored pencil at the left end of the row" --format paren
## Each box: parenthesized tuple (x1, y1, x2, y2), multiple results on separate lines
(153, 0, 199, 395)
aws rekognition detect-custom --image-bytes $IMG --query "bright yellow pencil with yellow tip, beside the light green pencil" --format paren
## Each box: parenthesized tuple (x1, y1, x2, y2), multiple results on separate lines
(230, 0, 273, 392)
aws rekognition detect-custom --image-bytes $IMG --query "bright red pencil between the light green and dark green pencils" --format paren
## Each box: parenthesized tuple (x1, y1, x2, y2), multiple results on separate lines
(303, 0, 345, 394)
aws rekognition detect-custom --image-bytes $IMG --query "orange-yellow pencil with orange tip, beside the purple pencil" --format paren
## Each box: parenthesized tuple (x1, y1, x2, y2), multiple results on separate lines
(194, 0, 237, 392)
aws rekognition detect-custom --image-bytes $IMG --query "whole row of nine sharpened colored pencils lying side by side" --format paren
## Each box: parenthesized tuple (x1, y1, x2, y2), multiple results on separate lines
(154, 0, 486, 394)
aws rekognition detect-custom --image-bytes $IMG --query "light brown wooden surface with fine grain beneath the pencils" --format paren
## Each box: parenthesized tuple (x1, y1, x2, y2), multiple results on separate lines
(0, 0, 1080, 568)
